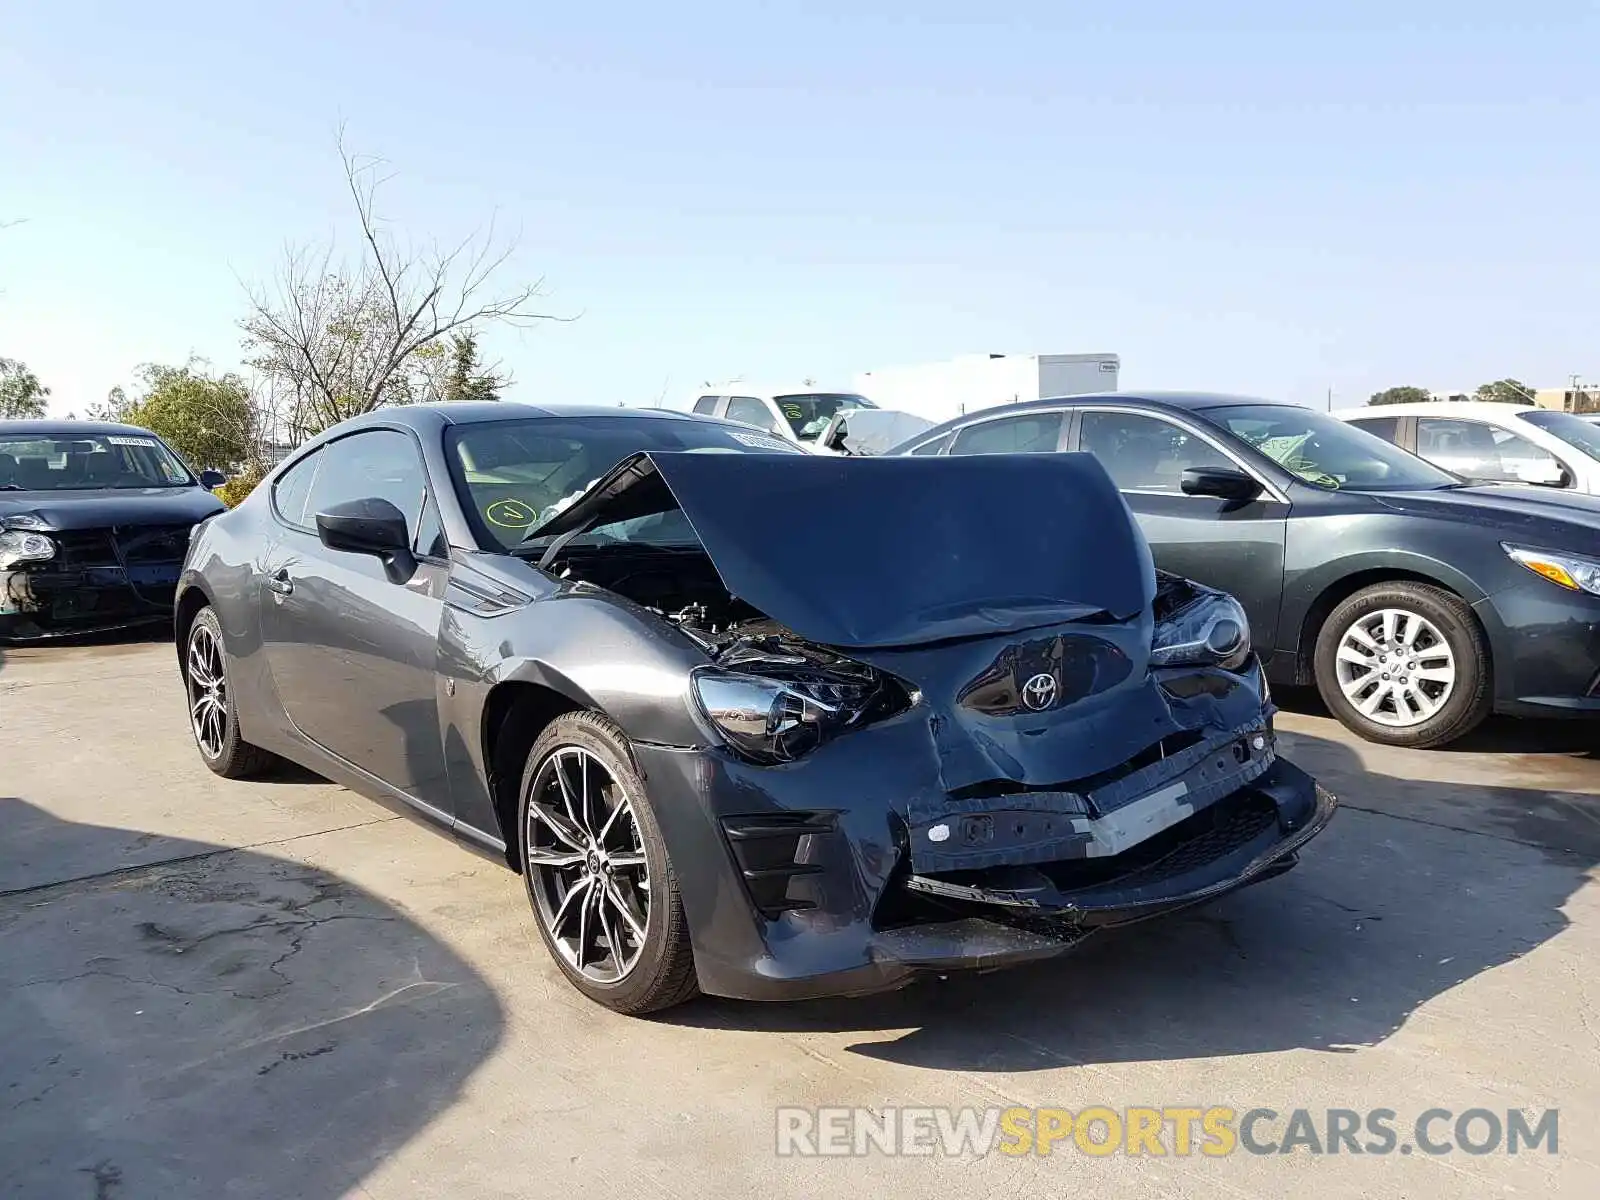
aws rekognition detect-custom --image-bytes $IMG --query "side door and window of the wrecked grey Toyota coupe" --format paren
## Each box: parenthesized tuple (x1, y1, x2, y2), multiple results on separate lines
(261, 429, 451, 818)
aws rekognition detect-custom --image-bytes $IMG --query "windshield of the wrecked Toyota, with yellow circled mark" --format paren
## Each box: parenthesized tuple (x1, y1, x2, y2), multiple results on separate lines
(446, 418, 805, 550)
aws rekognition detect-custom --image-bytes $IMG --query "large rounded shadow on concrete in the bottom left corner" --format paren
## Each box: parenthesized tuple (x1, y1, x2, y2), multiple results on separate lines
(0, 797, 504, 1200)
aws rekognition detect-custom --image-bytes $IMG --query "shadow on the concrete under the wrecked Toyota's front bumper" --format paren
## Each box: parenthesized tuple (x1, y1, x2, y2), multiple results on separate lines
(667, 733, 1600, 1072)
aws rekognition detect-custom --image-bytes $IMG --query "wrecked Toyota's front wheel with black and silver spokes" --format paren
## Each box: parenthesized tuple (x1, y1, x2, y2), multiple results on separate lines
(518, 712, 699, 1014)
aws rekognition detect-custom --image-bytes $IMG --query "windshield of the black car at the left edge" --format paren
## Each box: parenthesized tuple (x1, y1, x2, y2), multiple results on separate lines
(0, 434, 195, 491)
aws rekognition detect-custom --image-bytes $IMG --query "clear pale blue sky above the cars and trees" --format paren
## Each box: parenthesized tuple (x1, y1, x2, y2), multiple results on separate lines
(0, 0, 1600, 411)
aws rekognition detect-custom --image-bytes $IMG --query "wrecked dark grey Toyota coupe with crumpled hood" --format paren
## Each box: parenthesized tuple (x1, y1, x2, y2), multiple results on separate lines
(176, 403, 1334, 1013)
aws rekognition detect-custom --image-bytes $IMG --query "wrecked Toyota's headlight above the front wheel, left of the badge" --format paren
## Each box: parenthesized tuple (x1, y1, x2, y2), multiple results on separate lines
(691, 667, 885, 766)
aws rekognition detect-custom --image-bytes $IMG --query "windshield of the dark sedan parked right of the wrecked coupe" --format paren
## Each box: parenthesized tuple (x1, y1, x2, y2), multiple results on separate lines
(1198, 405, 1462, 491)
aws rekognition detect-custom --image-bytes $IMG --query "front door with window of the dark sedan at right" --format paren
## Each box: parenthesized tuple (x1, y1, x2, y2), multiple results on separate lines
(1075, 408, 1290, 650)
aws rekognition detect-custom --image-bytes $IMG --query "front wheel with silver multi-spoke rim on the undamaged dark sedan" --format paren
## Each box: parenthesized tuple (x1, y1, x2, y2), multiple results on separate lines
(1315, 582, 1494, 749)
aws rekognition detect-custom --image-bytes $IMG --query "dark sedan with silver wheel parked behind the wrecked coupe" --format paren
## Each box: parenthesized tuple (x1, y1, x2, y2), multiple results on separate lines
(890, 392, 1600, 746)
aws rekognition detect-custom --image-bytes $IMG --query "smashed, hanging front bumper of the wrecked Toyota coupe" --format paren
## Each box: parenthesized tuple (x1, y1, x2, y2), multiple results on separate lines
(635, 722, 1336, 1000)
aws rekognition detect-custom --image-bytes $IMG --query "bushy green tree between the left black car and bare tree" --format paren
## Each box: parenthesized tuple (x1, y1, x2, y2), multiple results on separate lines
(126, 358, 259, 470)
